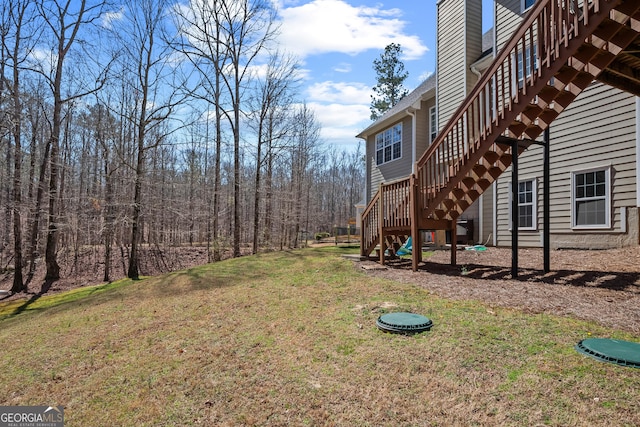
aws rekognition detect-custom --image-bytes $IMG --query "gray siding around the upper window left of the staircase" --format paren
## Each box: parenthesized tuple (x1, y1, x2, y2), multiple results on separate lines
(367, 116, 413, 202)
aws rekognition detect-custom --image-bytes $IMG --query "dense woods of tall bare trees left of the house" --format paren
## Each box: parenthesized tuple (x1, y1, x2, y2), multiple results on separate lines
(0, 0, 364, 292)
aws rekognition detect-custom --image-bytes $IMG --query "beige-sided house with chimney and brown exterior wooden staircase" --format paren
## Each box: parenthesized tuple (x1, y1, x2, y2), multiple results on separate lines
(358, 0, 640, 268)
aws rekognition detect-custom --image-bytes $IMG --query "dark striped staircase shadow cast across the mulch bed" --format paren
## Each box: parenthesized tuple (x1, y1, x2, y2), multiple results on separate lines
(387, 258, 640, 293)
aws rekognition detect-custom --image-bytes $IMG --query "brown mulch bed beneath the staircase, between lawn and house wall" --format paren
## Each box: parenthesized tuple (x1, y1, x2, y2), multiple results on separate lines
(357, 247, 640, 334)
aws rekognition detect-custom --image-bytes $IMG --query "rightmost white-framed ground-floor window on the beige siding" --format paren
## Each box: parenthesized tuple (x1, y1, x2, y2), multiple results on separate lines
(571, 168, 611, 228)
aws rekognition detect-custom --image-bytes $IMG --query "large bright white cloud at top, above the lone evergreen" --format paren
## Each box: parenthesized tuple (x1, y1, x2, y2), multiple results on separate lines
(280, 0, 428, 60)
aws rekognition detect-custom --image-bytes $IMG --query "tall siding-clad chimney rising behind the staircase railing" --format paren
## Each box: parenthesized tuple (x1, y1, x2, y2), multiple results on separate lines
(436, 0, 482, 129)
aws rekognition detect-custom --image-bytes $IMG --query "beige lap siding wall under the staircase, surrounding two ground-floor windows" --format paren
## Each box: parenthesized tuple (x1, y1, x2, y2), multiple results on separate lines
(497, 83, 637, 248)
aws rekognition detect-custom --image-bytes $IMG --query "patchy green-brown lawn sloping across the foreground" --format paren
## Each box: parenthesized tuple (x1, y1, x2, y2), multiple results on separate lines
(0, 247, 640, 426)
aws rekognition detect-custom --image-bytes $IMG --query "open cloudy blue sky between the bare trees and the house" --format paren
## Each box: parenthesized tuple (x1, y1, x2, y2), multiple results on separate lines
(274, 0, 492, 150)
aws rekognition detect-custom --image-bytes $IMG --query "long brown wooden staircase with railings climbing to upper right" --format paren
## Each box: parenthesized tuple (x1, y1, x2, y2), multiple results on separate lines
(361, 0, 640, 270)
